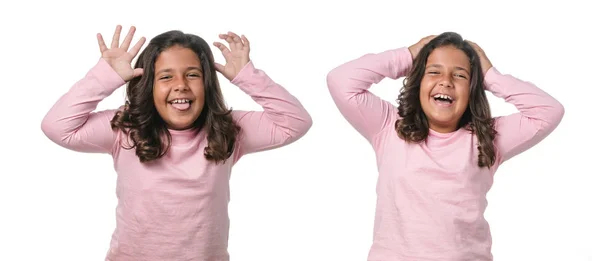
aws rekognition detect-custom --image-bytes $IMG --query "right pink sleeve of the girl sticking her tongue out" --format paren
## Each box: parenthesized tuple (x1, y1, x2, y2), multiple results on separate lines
(231, 61, 312, 161)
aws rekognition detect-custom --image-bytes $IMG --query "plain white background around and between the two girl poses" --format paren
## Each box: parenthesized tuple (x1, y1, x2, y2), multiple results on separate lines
(0, 0, 600, 261)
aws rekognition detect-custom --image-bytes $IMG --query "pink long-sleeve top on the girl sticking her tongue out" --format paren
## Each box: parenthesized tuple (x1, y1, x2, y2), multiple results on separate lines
(42, 59, 312, 261)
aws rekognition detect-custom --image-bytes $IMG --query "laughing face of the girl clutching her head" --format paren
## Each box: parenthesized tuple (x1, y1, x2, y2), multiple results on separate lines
(419, 46, 471, 133)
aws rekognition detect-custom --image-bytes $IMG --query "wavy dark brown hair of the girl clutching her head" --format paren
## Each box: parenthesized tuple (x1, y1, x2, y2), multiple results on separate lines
(396, 32, 496, 168)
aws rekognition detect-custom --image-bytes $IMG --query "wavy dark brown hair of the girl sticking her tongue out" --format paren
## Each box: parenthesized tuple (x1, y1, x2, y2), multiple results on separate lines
(111, 30, 240, 163)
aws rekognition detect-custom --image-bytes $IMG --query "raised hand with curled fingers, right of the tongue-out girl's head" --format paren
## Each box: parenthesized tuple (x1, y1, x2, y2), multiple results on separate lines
(213, 32, 250, 81)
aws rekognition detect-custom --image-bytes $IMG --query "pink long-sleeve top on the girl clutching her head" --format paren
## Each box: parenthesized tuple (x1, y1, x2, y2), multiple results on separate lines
(327, 45, 564, 261)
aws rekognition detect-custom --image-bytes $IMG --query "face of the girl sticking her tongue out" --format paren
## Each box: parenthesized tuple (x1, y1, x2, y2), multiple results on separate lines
(153, 46, 204, 130)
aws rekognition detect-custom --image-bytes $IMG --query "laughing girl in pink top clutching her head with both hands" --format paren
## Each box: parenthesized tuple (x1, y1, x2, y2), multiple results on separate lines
(327, 32, 564, 261)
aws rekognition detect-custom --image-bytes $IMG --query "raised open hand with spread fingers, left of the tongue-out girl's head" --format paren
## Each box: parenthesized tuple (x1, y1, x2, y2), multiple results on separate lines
(97, 25, 146, 82)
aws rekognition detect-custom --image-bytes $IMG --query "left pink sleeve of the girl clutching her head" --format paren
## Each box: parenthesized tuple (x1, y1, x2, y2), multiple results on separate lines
(327, 47, 412, 142)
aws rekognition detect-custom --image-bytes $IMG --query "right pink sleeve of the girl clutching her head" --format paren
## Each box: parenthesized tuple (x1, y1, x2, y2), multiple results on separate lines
(485, 67, 564, 164)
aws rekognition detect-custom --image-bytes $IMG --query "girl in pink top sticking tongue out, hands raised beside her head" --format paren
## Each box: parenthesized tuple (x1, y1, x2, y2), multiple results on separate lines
(42, 26, 312, 261)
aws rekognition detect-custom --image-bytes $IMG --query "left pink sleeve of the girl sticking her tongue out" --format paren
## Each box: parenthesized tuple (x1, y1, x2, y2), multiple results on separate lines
(41, 59, 124, 154)
